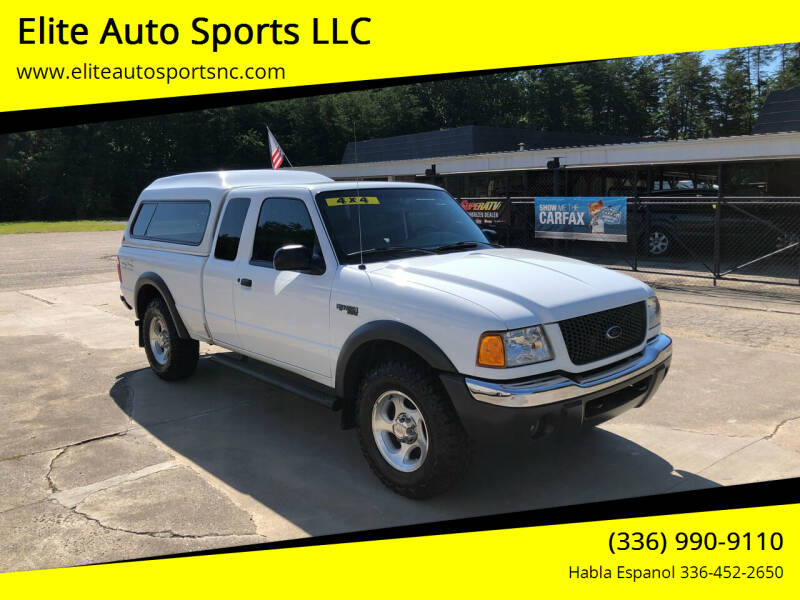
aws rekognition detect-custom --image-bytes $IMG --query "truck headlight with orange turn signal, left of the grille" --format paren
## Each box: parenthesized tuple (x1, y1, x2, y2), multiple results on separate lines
(477, 326, 553, 368)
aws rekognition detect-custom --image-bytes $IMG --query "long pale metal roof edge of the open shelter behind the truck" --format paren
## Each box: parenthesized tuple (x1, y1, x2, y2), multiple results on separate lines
(298, 131, 800, 179)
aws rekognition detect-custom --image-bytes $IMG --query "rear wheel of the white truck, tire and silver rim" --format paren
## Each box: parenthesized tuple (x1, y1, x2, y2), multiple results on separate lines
(142, 298, 200, 381)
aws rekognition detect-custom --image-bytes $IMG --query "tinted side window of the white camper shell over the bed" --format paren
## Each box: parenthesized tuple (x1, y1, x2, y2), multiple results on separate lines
(131, 200, 211, 246)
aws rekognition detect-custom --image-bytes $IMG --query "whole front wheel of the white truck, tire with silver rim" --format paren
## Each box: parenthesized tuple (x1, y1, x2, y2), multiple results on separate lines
(357, 362, 471, 498)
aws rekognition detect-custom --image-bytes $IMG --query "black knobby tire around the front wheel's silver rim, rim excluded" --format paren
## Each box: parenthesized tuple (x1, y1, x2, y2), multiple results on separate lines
(356, 361, 472, 499)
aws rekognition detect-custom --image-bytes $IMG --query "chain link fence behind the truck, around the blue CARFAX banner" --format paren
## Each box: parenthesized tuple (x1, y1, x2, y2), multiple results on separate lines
(460, 193, 800, 285)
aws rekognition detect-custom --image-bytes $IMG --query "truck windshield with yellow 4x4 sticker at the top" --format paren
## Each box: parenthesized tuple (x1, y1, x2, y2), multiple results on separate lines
(317, 188, 491, 264)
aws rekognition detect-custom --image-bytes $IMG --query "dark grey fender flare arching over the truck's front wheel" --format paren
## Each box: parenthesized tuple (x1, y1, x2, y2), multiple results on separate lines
(336, 321, 457, 398)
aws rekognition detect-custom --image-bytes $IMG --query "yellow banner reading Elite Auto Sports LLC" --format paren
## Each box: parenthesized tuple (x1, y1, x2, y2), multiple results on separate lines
(0, 0, 800, 116)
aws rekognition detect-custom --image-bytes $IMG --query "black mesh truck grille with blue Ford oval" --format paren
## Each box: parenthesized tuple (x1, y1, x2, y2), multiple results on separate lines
(558, 302, 647, 365)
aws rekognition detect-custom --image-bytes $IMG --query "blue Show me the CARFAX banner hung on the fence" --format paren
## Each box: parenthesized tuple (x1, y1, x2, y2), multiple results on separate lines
(535, 196, 628, 242)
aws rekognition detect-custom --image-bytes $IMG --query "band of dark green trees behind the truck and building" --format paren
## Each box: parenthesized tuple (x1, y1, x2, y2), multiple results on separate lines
(0, 44, 800, 220)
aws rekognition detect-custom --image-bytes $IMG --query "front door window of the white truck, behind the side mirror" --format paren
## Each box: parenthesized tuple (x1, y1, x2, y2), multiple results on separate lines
(252, 198, 319, 265)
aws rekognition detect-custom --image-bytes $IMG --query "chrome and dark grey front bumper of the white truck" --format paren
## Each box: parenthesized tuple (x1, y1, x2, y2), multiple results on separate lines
(441, 334, 672, 438)
